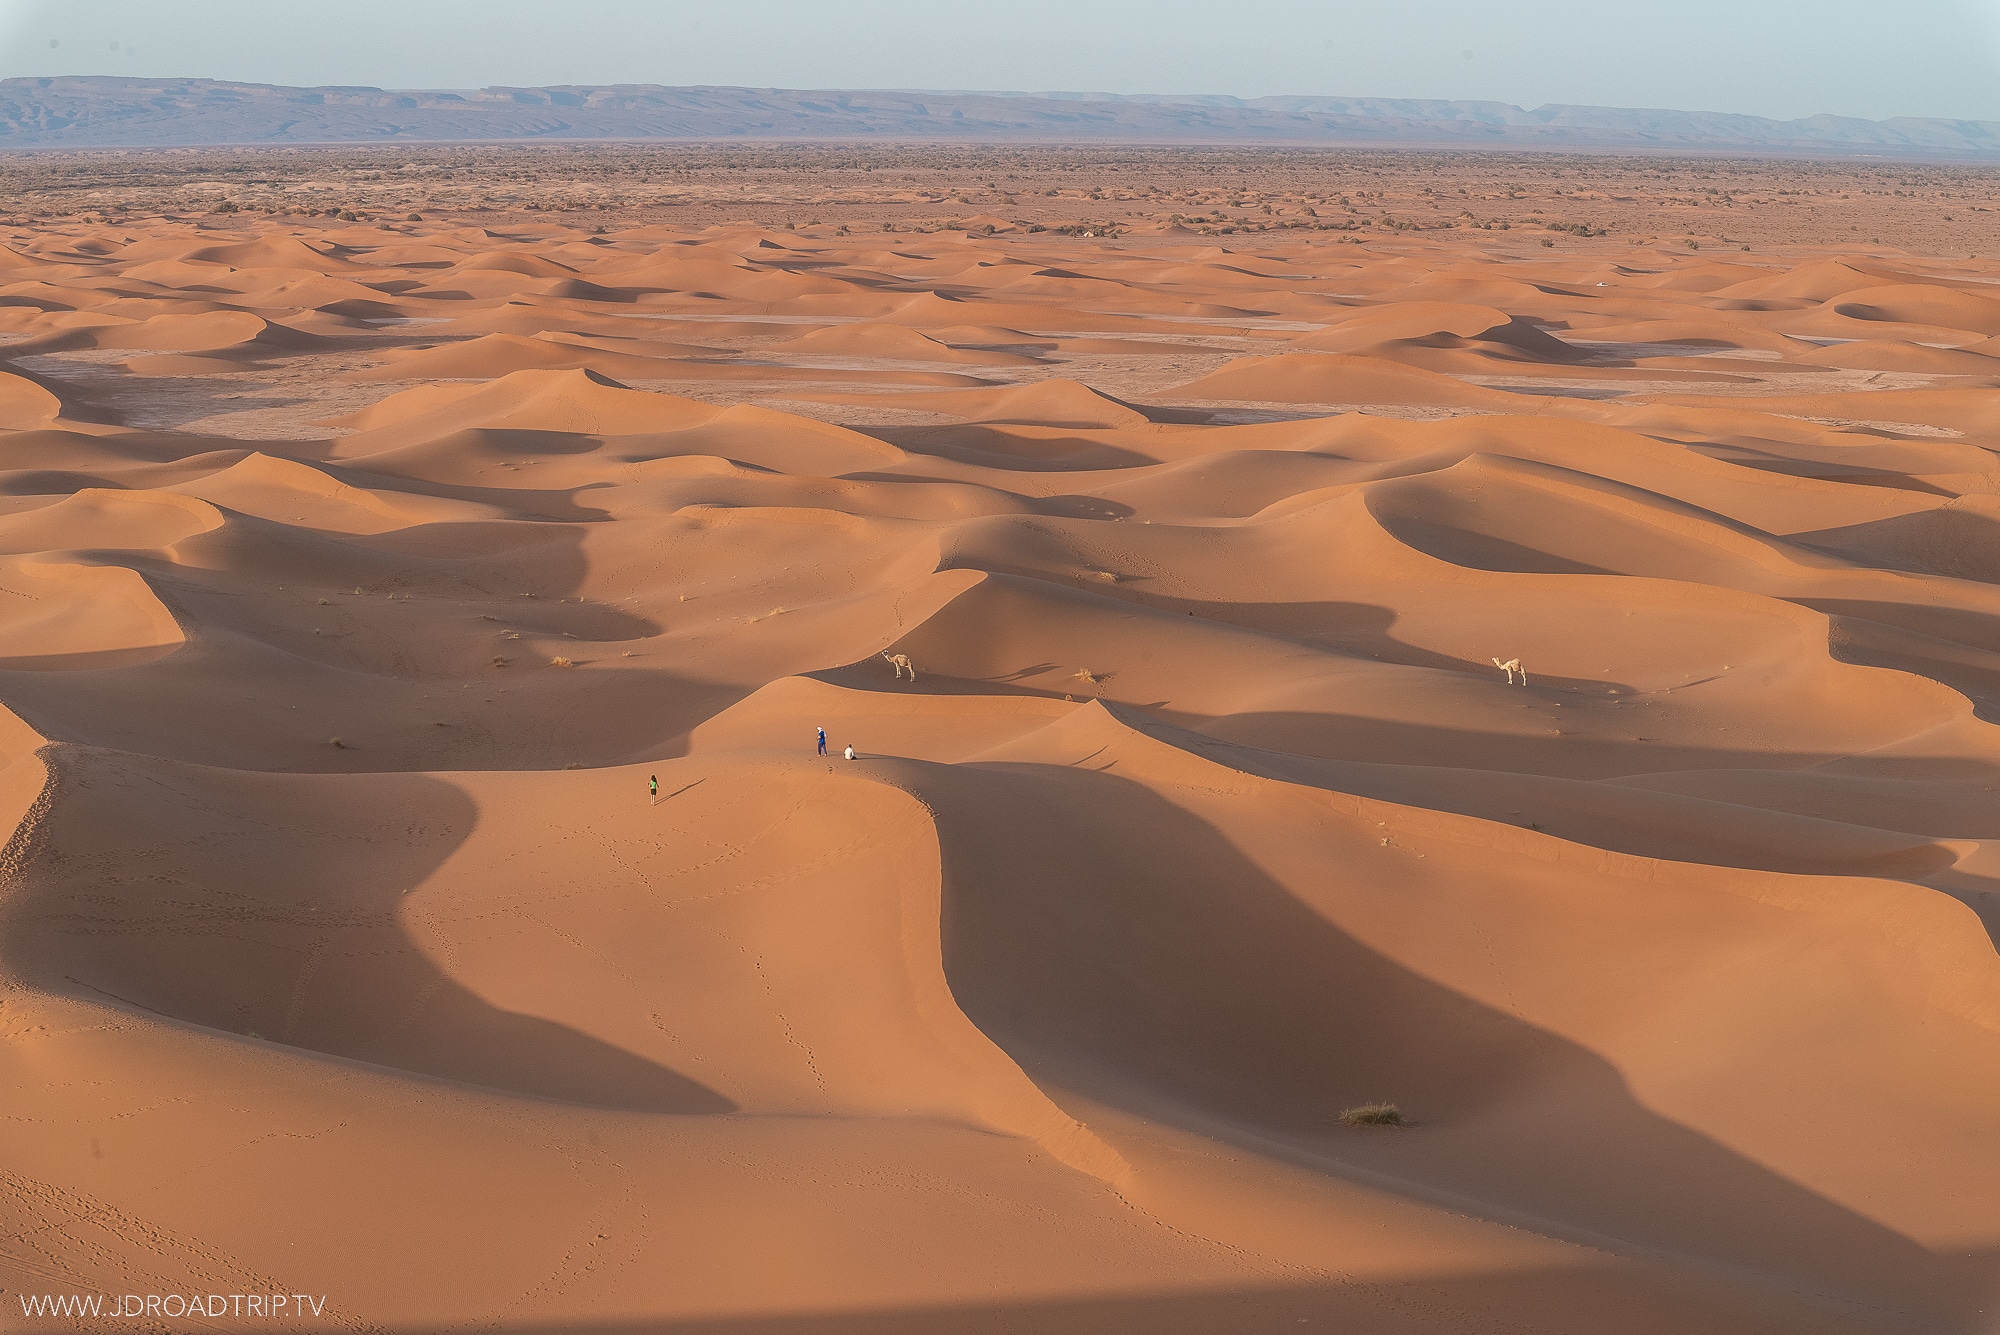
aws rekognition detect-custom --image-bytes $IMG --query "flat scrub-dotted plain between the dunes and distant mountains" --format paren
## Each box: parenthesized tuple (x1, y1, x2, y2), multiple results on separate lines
(4, 144, 1988, 250)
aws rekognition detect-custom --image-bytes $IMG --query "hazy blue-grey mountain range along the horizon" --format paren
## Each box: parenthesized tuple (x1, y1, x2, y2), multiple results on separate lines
(0, 78, 2000, 160)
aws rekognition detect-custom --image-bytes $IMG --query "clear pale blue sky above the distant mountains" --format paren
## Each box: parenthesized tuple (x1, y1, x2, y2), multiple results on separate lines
(0, 0, 2000, 120)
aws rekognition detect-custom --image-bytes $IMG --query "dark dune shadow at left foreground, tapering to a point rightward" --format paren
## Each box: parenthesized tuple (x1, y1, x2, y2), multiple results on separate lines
(0, 747, 736, 1113)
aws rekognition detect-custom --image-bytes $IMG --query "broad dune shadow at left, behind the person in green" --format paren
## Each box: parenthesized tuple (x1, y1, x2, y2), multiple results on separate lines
(0, 512, 748, 773)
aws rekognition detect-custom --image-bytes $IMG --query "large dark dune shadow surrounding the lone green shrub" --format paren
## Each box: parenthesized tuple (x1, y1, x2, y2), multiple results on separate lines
(924, 763, 1996, 1323)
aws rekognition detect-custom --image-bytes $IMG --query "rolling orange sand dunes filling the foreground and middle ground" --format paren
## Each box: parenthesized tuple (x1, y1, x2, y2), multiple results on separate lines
(0, 158, 2000, 1335)
